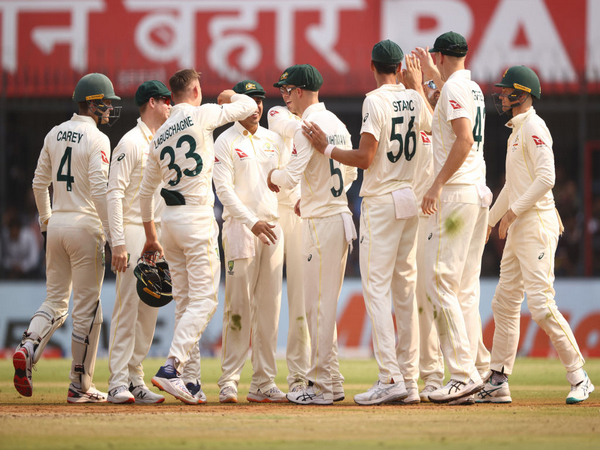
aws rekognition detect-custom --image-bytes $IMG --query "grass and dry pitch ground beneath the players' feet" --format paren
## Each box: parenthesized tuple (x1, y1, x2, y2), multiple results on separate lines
(0, 359, 600, 450)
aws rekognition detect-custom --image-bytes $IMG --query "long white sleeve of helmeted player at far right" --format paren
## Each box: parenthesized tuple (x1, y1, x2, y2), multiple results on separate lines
(510, 124, 556, 216)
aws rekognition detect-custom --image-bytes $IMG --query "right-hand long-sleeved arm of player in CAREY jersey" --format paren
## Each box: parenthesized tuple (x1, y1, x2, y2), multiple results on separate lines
(88, 134, 112, 245)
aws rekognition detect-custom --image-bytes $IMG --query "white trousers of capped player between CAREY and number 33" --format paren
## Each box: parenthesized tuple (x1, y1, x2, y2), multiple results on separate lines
(108, 223, 159, 391)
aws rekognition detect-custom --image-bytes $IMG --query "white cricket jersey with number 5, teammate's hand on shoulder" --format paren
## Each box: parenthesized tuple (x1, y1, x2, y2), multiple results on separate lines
(271, 103, 357, 218)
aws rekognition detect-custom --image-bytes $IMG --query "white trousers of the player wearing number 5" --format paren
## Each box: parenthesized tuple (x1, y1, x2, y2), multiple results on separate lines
(302, 214, 348, 401)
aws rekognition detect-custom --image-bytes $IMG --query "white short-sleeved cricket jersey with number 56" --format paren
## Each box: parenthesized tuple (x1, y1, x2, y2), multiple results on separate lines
(360, 84, 431, 197)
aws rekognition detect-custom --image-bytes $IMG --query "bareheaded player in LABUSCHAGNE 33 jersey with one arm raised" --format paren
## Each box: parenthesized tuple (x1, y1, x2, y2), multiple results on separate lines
(139, 69, 256, 405)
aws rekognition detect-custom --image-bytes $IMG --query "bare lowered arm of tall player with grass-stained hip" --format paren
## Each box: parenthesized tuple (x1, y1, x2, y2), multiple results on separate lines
(421, 117, 475, 214)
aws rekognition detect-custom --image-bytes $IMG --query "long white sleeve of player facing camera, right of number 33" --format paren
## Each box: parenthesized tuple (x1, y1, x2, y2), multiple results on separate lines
(213, 134, 259, 230)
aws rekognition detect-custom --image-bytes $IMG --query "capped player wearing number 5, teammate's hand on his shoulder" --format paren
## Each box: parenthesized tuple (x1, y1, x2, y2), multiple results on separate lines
(268, 64, 356, 405)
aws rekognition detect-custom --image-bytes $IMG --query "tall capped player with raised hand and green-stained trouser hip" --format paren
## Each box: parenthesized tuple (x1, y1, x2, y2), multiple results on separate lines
(417, 32, 492, 403)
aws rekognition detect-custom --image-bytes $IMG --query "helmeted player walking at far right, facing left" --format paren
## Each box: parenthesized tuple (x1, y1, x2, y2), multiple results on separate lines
(476, 66, 594, 404)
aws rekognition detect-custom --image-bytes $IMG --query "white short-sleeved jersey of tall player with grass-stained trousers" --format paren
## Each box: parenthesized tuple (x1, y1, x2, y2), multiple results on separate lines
(432, 70, 485, 185)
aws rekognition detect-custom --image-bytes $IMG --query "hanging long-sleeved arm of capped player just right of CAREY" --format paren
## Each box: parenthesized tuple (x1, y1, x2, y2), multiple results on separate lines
(106, 140, 141, 272)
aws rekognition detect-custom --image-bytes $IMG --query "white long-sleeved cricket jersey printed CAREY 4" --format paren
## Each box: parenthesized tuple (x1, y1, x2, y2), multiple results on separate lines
(33, 114, 110, 231)
